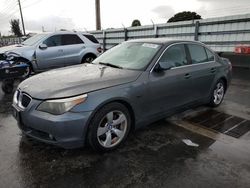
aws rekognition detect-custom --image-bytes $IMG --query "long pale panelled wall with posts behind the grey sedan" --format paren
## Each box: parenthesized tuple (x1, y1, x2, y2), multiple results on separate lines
(90, 14, 250, 52)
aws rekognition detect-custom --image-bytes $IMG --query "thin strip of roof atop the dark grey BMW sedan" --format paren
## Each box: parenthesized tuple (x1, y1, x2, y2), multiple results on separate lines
(128, 38, 202, 44)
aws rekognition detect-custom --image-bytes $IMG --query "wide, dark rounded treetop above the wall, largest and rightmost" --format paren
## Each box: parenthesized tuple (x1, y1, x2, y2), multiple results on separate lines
(168, 11, 202, 23)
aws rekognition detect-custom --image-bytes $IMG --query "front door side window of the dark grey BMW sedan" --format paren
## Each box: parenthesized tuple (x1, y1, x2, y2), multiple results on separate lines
(160, 44, 188, 68)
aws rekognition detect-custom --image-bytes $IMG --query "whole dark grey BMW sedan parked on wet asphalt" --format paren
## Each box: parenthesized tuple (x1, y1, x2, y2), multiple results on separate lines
(13, 38, 232, 152)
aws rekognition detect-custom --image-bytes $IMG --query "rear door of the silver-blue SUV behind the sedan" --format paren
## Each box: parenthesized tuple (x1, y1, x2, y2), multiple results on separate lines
(62, 34, 85, 65)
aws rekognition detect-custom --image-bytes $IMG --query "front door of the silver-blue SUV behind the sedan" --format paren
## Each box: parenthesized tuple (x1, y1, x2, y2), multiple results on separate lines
(36, 35, 64, 70)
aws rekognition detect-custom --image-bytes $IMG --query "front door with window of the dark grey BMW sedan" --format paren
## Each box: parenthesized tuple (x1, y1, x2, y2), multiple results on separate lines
(147, 44, 193, 114)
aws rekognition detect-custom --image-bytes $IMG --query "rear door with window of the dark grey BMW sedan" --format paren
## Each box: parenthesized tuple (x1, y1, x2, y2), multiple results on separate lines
(187, 43, 220, 100)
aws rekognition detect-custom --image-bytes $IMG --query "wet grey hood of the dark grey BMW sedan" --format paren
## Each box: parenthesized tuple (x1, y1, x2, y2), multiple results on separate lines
(19, 64, 141, 100)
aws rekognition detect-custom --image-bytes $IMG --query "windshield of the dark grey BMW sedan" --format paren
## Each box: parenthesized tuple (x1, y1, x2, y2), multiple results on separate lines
(93, 42, 161, 70)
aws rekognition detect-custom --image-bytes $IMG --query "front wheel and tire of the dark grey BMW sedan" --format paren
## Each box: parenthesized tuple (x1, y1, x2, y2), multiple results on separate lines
(88, 103, 131, 152)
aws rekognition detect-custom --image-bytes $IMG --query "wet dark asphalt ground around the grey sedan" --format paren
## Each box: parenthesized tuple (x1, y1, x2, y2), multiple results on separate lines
(0, 68, 250, 188)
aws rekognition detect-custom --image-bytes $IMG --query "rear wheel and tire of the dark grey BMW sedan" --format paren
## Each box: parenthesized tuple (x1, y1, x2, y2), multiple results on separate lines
(209, 80, 226, 107)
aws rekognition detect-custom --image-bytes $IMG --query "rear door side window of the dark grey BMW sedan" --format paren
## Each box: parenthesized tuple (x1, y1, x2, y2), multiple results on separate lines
(187, 44, 208, 64)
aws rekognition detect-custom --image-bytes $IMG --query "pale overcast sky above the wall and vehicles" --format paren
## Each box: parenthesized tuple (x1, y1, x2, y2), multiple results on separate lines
(0, 0, 250, 35)
